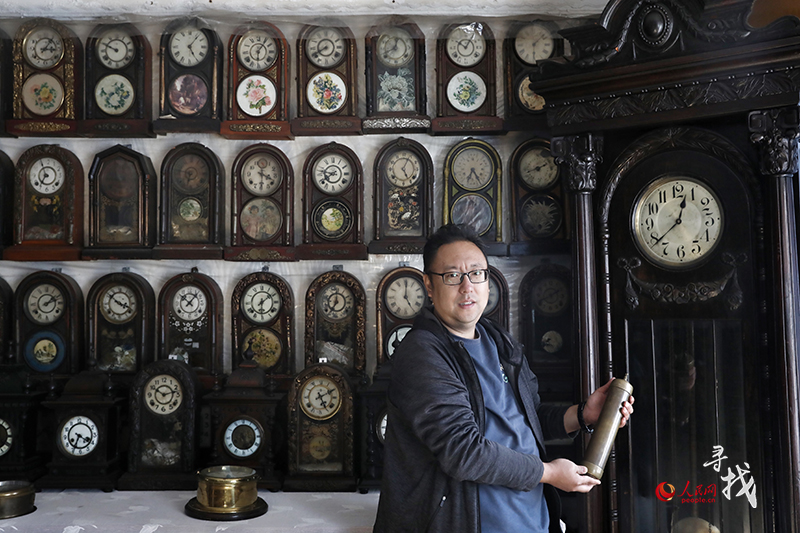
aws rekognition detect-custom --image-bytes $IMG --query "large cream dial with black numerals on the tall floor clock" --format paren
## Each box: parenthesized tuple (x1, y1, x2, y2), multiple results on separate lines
(632, 176, 725, 269)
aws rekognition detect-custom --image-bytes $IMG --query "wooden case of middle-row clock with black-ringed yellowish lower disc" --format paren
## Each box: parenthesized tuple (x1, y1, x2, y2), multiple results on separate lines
(297, 142, 367, 259)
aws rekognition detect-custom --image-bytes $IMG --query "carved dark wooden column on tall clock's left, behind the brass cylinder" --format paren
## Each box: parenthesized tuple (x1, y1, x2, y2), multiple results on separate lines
(550, 134, 604, 533)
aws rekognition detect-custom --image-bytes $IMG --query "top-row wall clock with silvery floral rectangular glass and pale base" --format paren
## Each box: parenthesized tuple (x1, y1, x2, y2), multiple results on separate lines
(361, 17, 431, 133)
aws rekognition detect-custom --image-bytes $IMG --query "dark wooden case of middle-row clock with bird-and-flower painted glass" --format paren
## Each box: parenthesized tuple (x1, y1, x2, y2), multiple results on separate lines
(369, 137, 434, 254)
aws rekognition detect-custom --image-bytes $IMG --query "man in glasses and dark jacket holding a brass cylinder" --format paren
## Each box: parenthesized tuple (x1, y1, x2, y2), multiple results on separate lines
(375, 224, 633, 533)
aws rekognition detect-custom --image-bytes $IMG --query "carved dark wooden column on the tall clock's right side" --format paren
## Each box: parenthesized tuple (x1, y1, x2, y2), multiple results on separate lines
(748, 107, 800, 533)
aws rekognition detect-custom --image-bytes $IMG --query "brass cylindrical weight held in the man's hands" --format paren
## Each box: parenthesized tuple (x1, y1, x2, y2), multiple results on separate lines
(583, 375, 633, 479)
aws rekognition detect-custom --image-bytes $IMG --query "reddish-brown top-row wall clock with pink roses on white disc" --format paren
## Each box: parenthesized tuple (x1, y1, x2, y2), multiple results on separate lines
(220, 22, 294, 139)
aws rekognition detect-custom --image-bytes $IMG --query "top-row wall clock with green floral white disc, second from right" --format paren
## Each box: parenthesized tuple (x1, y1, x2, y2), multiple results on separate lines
(431, 21, 503, 135)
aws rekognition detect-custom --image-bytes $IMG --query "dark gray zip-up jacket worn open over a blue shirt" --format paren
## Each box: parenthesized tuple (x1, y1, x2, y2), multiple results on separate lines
(374, 309, 572, 533)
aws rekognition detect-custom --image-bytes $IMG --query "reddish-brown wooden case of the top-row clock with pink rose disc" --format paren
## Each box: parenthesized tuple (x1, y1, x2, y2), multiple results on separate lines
(220, 21, 294, 140)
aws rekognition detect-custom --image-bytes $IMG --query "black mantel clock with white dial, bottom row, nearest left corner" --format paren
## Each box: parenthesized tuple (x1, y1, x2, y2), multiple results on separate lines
(36, 370, 126, 492)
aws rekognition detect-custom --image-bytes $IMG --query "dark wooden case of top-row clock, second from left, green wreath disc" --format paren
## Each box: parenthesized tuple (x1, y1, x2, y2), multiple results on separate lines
(80, 23, 155, 138)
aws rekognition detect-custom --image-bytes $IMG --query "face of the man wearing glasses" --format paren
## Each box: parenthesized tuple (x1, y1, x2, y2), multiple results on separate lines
(423, 241, 489, 339)
